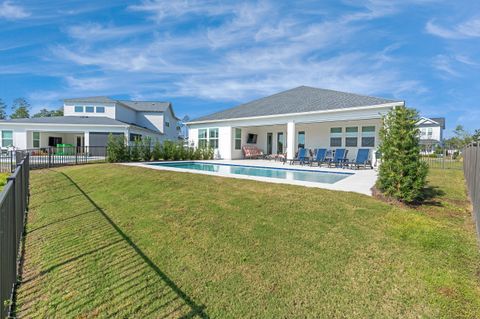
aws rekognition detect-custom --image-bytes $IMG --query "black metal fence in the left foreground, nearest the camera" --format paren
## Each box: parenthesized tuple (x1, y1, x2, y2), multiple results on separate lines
(0, 153, 30, 318)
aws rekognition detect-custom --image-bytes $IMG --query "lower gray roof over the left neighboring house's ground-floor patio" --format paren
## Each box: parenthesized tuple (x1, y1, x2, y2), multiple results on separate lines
(0, 116, 160, 134)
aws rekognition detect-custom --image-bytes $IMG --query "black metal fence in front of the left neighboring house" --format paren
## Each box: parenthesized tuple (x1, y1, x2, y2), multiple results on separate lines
(0, 146, 107, 172)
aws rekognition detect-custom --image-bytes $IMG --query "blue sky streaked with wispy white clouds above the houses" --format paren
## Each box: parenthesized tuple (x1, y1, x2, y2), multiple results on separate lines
(0, 0, 480, 136)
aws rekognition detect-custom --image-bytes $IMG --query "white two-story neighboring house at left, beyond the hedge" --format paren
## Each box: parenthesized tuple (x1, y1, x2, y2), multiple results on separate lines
(0, 96, 180, 149)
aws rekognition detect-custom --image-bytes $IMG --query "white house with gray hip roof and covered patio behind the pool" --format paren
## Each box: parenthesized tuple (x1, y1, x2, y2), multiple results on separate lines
(187, 86, 404, 162)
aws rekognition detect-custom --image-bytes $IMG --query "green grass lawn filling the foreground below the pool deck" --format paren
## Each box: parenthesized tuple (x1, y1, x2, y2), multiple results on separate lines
(18, 164, 480, 318)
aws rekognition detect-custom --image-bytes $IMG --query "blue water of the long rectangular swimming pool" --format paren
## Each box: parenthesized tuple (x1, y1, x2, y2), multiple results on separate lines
(149, 162, 352, 184)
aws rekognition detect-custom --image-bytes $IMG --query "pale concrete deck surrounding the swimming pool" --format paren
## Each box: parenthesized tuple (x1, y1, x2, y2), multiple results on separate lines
(123, 160, 377, 196)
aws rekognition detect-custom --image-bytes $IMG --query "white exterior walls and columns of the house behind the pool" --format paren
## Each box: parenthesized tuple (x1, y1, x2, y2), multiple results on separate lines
(188, 107, 391, 159)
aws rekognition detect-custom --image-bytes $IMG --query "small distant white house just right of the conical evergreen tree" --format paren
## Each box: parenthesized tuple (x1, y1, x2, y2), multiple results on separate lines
(417, 117, 445, 154)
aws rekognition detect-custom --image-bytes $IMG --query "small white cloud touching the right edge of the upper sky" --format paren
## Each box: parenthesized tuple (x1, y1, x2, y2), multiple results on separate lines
(425, 17, 480, 40)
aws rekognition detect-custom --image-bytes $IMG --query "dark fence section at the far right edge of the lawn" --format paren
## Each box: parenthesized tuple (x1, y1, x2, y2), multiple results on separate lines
(463, 142, 480, 240)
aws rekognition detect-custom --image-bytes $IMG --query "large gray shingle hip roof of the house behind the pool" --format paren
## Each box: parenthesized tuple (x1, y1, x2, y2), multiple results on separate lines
(191, 86, 402, 122)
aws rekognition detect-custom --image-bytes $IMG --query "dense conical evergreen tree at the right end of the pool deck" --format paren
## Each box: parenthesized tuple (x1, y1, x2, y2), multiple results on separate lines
(377, 106, 428, 203)
